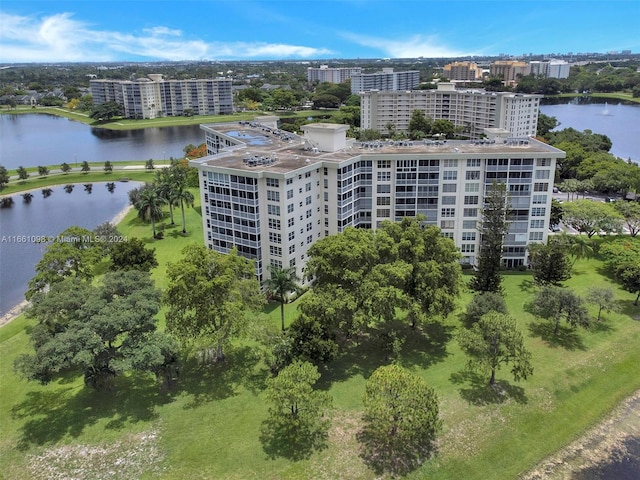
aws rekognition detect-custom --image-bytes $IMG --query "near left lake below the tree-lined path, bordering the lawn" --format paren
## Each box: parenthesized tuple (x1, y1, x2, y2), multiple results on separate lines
(0, 182, 140, 316)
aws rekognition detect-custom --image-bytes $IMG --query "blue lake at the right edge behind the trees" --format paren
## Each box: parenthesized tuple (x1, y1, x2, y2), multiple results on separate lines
(540, 98, 640, 163)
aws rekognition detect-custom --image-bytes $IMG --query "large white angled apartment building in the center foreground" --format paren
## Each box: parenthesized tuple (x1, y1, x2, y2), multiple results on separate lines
(190, 118, 564, 281)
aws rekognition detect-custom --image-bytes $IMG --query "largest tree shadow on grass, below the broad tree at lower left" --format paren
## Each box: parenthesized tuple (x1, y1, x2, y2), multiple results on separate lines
(11, 374, 173, 450)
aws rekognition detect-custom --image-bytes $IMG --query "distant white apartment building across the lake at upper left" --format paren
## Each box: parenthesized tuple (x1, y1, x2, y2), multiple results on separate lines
(89, 74, 233, 118)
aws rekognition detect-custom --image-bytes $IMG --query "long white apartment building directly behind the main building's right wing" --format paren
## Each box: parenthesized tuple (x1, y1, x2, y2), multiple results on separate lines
(360, 83, 543, 138)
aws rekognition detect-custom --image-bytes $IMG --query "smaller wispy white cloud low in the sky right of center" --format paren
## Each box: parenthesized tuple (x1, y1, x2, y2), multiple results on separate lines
(341, 32, 474, 58)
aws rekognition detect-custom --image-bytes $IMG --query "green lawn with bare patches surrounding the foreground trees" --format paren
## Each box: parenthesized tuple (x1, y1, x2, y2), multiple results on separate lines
(0, 197, 640, 480)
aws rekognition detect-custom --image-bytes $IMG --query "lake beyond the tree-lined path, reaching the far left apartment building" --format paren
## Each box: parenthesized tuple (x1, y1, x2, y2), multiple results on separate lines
(0, 114, 204, 169)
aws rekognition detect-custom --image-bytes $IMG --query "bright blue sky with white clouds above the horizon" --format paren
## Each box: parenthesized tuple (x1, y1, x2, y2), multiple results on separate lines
(0, 0, 640, 63)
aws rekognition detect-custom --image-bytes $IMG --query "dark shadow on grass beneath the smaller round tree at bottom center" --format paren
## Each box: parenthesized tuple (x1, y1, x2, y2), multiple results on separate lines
(260, 415, 329, 461)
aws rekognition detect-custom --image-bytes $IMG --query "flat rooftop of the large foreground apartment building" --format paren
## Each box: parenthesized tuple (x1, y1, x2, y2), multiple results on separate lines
(192, 122, 564, 173)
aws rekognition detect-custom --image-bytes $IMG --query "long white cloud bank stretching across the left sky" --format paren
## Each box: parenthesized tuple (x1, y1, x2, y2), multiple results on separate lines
(0, 12, 332, 63)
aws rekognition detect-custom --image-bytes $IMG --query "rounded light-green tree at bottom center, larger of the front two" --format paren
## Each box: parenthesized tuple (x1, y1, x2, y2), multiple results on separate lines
(360, 364, 442, 475)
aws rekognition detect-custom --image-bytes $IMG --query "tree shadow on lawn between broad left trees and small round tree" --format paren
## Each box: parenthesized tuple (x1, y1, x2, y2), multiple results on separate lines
(178, 347, 267, 409)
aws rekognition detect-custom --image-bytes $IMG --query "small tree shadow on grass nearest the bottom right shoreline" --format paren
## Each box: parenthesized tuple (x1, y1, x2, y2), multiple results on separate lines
(450, 370, 529, 406)
